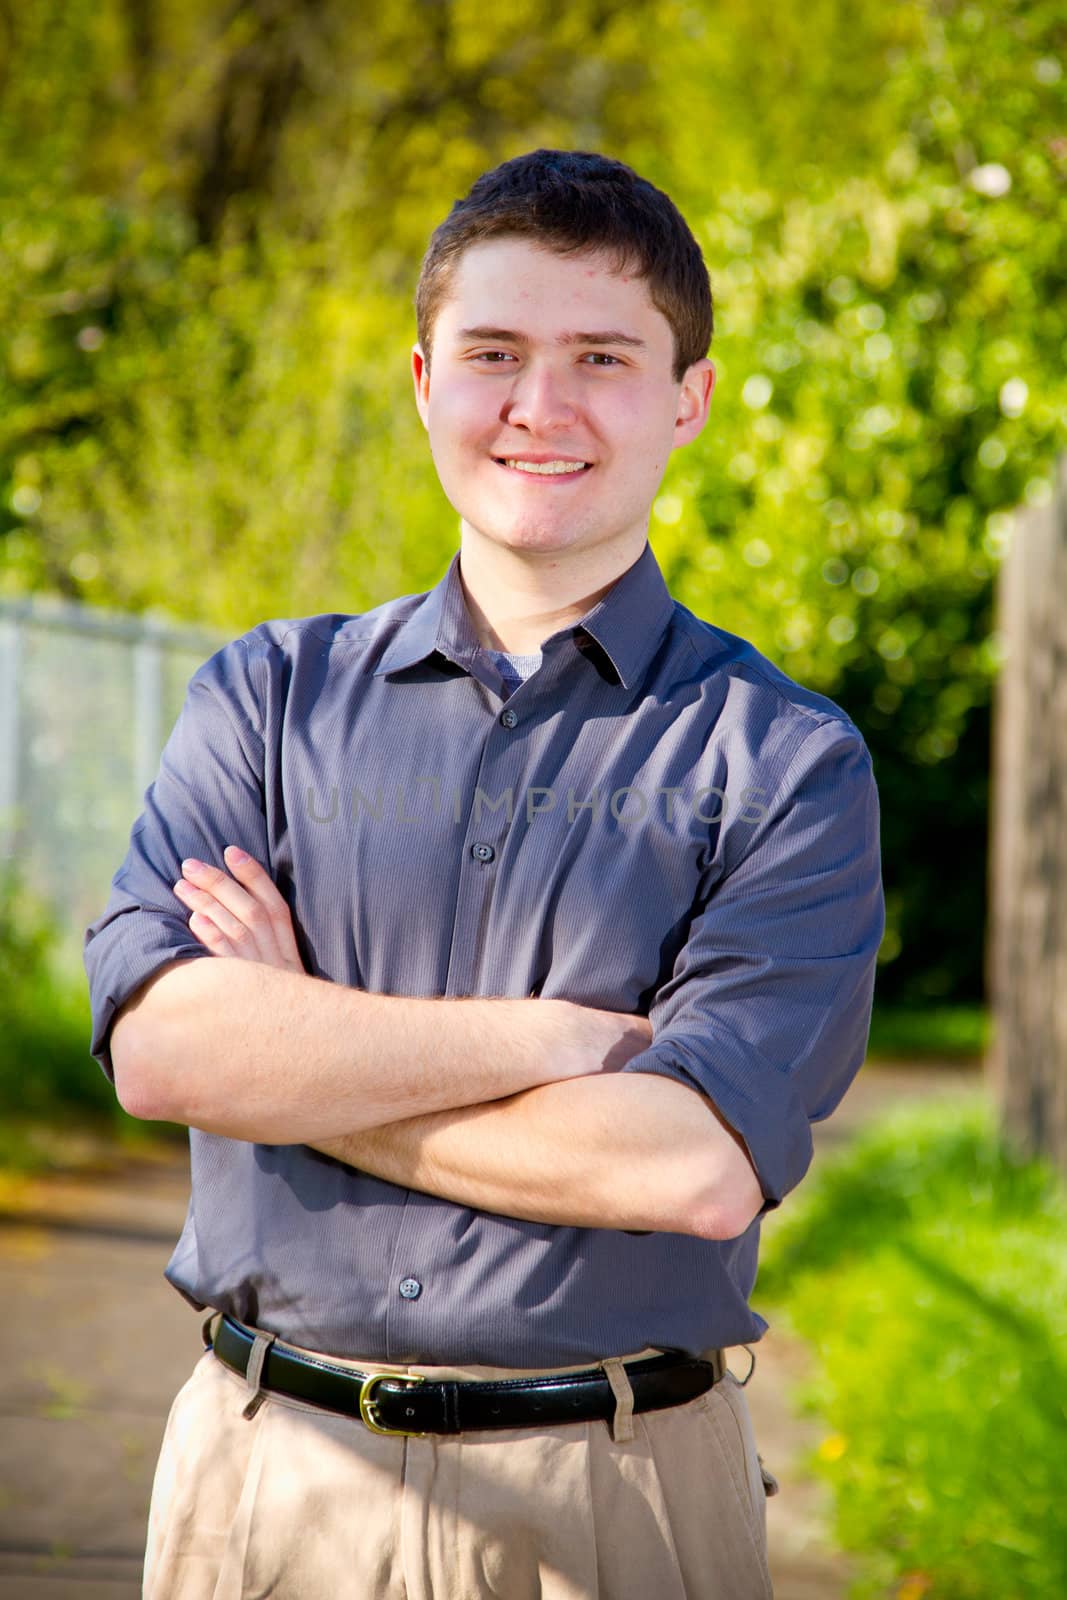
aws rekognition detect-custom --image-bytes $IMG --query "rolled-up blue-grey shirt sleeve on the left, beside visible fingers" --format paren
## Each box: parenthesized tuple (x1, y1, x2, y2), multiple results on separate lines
(85, 638, 269, 1083)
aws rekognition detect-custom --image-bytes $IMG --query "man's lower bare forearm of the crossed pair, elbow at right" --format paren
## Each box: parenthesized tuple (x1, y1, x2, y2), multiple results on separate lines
(310, 1072, 763, 1238)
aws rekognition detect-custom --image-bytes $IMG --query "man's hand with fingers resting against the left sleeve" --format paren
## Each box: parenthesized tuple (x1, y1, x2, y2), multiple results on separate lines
(174, 845, 306, 973)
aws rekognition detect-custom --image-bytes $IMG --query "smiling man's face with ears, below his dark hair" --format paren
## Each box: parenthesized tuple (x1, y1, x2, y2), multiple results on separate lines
(413, 238, 715, 560)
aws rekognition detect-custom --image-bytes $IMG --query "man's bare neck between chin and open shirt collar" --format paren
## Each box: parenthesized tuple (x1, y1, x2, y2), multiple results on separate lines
(459, 522, 648, 656)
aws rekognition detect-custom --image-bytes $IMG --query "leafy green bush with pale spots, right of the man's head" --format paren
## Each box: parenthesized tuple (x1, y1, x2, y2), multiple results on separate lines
(646, 3, 1067, 1006)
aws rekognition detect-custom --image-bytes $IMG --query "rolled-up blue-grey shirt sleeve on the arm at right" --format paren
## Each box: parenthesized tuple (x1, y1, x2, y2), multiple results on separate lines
(624, 722, 885, 1216)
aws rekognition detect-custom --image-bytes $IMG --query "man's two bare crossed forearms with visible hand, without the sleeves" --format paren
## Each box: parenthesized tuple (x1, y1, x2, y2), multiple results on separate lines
(110, 846, 763, 1238)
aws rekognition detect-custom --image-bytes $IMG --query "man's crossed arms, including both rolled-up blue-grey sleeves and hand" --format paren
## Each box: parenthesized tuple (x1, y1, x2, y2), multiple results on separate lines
(97, 642, 885, 1238)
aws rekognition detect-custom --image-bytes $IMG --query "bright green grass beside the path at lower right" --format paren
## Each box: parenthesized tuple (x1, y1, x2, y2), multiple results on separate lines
(755, 1098, 1067, 1600)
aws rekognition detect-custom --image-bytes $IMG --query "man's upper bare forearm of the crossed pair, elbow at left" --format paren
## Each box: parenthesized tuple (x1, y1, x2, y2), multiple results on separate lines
(112, 958, 620, 1144)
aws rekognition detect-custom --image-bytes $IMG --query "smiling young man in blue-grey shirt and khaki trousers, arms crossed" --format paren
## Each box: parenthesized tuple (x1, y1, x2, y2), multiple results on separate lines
(86, 150, 883, 1600)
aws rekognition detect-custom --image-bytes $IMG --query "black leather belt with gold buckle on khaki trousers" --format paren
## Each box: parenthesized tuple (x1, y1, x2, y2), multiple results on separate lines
(205, 1315, 717, 1434)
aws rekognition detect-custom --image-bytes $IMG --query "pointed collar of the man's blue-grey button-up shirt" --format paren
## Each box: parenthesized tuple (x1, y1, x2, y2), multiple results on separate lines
(374, 541, 675, 690)
